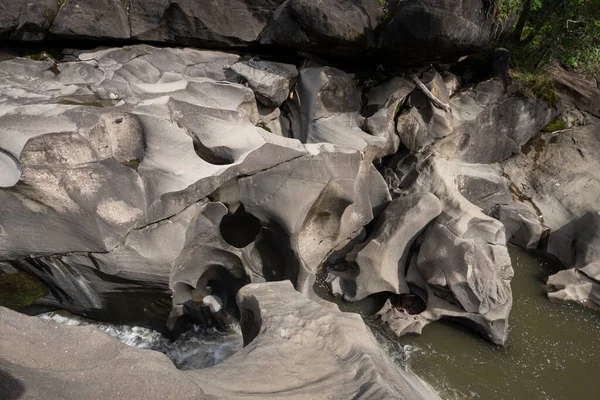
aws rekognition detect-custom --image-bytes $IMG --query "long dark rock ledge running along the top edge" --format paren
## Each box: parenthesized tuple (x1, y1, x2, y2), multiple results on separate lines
(0, 0, 500, 65)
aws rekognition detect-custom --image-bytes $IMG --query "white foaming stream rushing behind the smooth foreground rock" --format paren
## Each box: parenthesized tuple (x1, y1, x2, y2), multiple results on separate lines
(40, 311, 243, 369)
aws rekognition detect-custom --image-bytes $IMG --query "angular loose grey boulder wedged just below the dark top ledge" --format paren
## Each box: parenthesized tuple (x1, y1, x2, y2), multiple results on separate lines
(231, 60, 298, 107)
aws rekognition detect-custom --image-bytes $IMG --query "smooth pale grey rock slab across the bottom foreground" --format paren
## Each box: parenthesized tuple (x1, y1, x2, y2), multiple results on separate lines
(0, 282, 439, 399)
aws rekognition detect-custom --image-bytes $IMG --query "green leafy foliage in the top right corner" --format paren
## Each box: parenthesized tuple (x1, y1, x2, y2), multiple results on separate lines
(493, 0, 600, 72)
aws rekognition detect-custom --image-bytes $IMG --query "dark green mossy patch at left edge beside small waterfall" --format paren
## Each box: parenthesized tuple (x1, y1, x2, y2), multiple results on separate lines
(0, 272, 48, 310)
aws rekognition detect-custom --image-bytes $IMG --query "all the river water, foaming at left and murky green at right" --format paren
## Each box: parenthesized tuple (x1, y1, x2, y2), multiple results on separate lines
(42, 246, 600, 400)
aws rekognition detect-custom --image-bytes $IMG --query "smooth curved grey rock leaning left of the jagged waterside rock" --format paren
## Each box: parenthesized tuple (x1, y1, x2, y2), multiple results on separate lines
(332, 193, 441, 301)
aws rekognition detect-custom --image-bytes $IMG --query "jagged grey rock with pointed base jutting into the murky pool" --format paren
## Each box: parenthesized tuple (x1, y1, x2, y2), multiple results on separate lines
(376, 156, 513, 344)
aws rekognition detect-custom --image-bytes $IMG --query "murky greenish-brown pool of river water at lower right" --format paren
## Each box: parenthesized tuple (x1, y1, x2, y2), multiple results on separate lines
(401, 247, 600, 400)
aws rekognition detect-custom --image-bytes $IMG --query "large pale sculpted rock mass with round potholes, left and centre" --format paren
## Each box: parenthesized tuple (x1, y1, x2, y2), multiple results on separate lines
(0, 45, 393, 327)
